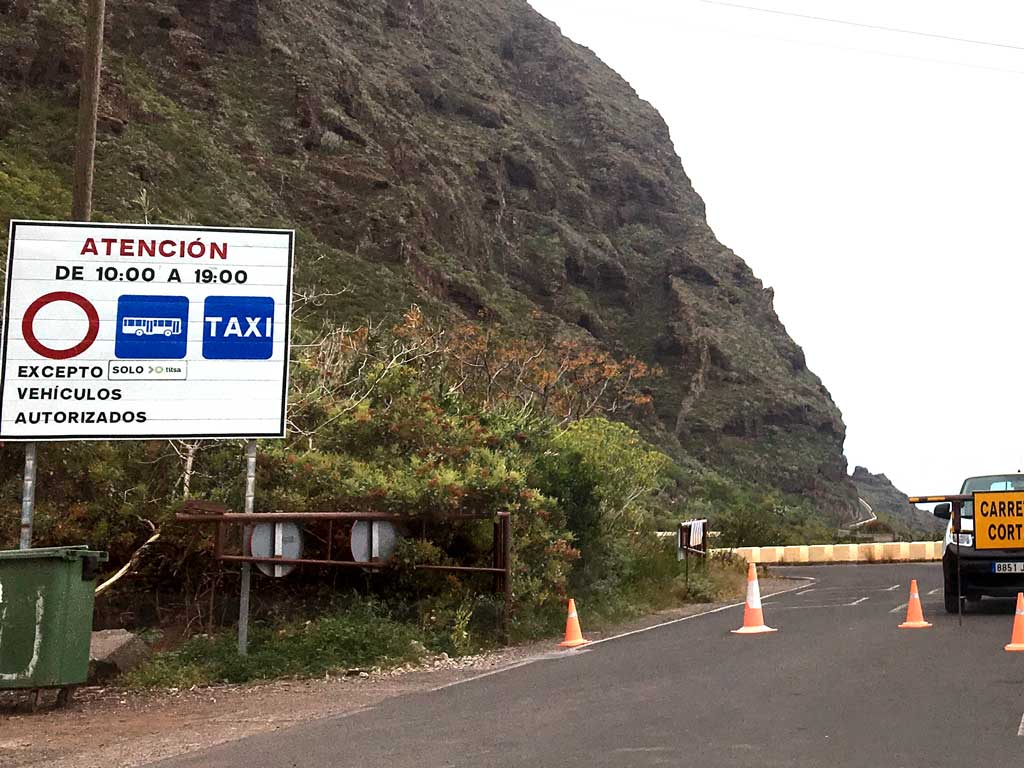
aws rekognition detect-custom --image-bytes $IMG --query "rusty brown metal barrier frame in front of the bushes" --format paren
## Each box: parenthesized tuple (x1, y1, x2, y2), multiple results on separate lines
(175, 501, 512, 637)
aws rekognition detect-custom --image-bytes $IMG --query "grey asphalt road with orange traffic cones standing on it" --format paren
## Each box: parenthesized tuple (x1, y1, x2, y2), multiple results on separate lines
(148, 564, 1024, 768)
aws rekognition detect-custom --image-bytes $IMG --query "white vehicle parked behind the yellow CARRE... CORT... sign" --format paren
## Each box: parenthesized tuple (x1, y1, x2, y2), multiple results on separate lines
(933, 474, 1024, 613)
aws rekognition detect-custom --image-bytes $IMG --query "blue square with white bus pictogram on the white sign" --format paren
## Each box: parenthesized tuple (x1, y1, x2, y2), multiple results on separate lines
(114, 295, 188, 359)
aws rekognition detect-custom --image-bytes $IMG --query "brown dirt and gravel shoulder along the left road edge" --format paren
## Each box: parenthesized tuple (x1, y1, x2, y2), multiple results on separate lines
(0, 579, 795, 768)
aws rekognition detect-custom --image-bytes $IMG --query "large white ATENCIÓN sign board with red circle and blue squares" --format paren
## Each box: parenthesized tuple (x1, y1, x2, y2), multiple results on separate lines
(0, 221, 295, 440)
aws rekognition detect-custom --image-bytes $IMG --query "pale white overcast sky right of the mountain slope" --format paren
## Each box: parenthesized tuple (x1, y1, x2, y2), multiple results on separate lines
(530, 0, 1024, 495)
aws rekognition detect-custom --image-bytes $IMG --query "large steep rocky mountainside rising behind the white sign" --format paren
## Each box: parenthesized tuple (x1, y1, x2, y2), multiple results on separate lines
(0, 0, 856, 520)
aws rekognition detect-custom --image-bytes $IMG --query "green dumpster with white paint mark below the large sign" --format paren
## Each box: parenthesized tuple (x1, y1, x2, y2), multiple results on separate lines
(0, 546, 106, 689)
